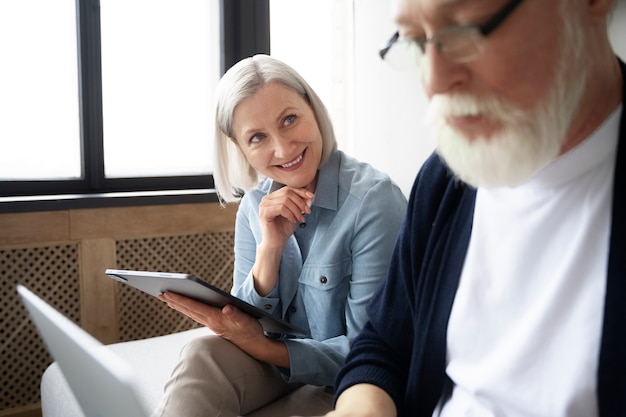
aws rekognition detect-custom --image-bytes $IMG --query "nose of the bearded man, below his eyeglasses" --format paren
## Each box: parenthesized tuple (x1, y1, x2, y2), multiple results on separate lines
(420, 44, 468, 99)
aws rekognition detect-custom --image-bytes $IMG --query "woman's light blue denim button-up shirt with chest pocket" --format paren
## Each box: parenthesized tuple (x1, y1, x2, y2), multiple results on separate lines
(232, 151, 406, 386)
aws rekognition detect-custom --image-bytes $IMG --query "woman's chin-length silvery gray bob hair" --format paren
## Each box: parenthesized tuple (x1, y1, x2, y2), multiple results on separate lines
(213, 55, 337, 203)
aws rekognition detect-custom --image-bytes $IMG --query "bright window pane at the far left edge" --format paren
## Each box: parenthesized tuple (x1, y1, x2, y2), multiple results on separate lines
(0, 0, 82, 180)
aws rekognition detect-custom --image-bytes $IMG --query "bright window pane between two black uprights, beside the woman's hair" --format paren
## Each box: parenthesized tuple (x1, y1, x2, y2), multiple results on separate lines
(100, 0, 220, 178)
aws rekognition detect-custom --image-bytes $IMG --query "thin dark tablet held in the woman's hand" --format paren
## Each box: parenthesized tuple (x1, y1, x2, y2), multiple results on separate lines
(105, 269, 306, 336)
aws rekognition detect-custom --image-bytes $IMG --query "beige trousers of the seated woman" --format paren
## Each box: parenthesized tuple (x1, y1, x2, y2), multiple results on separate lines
(152, 335, 333, 417)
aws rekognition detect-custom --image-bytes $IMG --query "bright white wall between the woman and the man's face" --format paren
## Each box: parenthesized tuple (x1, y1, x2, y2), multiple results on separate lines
(346, 1, 433, 195)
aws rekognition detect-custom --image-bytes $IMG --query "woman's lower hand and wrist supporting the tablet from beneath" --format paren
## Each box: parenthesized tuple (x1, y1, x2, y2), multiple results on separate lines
(159, 292, 289, 368)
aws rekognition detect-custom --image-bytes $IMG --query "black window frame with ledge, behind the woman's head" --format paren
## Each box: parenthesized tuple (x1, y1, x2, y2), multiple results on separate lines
(0, 0, 270, 212)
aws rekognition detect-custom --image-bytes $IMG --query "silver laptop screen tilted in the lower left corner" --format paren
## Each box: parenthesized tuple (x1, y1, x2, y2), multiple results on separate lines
(17, 285, 149, 417)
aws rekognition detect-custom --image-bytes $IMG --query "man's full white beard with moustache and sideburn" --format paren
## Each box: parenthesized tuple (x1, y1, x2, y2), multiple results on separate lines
(431, 11, 588, 187)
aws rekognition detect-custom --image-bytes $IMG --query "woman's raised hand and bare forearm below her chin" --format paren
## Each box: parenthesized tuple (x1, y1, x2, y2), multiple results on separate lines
(252, 187, 313, 296)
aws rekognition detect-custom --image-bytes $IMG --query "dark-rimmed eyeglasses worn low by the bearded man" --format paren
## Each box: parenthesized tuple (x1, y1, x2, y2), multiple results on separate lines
(379, 0, 523, 69)
